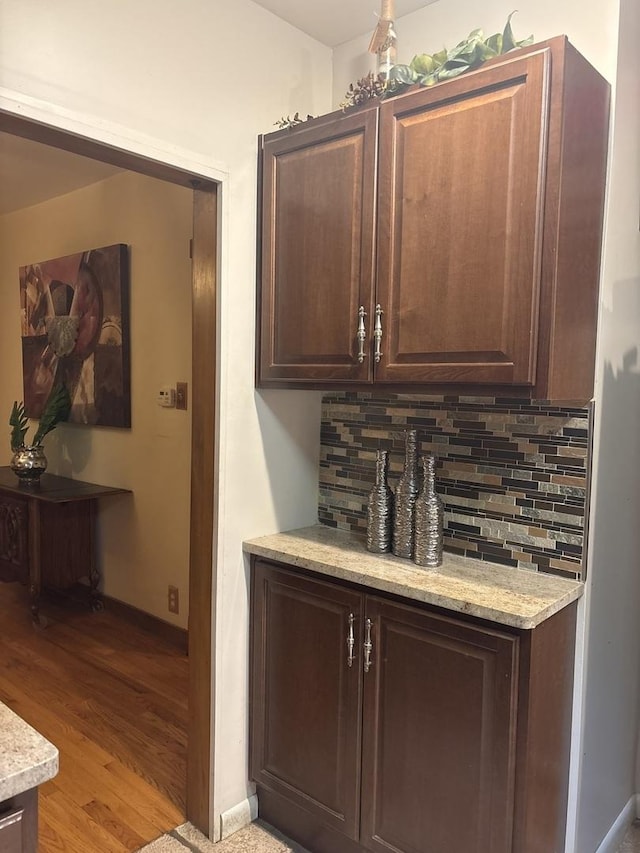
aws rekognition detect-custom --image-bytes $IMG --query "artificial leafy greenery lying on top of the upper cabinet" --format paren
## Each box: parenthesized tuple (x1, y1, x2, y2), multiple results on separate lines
(340, 12, 533, 110)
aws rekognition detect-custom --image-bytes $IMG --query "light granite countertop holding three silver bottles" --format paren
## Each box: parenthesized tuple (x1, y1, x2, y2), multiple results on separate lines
(243, 524, 584, 629)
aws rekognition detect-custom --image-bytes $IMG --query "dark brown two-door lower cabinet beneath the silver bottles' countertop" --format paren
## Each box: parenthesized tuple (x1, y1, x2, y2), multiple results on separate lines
(251, 558, 575, 853)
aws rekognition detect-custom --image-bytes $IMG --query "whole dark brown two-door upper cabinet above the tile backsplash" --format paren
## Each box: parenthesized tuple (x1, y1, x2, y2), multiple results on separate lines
(257, 36, 609, 401)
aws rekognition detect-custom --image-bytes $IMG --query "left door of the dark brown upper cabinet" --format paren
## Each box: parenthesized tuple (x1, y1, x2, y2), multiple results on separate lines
(259, 109, 378, 384)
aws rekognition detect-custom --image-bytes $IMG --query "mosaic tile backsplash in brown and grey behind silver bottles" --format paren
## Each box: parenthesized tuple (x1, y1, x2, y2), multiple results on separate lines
(318, 392, 592, 579)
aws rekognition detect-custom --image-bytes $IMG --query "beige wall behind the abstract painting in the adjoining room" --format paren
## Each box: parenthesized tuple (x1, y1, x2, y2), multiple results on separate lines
(0, 172, 193, 627)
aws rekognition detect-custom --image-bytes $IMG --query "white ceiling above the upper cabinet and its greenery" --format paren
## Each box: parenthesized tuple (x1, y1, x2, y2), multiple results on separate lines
(254, 0, 436, 47)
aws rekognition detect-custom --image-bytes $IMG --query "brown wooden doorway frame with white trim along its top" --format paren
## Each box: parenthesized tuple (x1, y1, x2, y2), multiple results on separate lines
(0, 105, 220, 836)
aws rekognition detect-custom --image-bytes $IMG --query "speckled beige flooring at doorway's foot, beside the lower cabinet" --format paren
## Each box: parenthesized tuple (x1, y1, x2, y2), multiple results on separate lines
(137, 820, 307, 853)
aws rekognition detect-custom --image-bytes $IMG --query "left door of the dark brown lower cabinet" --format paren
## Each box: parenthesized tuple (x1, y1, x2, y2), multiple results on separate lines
(251, 561, 362, 838)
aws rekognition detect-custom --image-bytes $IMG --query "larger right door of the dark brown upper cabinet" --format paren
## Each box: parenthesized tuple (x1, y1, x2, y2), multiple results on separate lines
(376, 50, 549, 385)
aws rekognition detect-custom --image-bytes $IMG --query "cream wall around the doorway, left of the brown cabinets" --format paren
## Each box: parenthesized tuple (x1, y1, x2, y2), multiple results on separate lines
(0, 0, 331, 836)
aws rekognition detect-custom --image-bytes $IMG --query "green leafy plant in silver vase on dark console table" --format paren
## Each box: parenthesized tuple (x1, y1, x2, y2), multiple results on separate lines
(9, 384, 71, 484)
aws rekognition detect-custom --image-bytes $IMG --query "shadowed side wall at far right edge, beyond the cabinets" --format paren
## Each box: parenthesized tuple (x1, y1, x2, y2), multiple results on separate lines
(575, 0, 640, 851)
